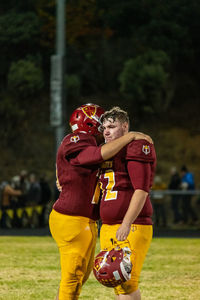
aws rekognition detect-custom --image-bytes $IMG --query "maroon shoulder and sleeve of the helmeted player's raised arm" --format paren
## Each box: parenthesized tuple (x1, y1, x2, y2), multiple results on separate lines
(64, 133, 103, 165)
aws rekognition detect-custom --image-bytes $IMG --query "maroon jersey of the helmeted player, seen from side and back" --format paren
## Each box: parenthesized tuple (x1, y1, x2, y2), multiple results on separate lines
(53, 133, 103, 220)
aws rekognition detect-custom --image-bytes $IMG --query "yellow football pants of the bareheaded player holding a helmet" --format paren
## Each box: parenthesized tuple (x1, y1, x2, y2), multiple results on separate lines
(100, 224, 153, 295)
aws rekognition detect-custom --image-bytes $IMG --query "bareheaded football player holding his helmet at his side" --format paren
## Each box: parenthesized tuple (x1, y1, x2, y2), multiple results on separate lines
(99, 107, 156, 300)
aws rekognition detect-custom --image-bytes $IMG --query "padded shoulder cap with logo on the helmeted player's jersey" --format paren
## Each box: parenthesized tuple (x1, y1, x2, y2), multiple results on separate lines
(61, 132, 97, 155)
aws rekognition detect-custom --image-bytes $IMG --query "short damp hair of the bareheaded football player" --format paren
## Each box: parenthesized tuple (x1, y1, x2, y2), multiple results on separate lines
(101, 106, 129, 125)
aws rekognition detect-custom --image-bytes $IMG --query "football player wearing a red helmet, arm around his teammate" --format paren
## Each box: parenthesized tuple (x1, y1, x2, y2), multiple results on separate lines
(49, 104, 151, 300)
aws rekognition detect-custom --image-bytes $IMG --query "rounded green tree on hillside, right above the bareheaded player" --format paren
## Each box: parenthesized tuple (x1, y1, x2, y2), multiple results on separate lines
(119, 50, 172, 113)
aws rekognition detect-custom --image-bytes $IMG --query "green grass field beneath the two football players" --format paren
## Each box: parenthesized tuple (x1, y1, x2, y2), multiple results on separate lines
(0, 236, 200, 300)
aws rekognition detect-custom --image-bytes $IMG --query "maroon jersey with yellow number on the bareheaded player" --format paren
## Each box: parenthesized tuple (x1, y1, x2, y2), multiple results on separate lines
(100, 140, 156, 225)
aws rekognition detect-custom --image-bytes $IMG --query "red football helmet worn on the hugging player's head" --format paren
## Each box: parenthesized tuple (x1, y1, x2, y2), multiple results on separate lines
(69, 103, 104, 136)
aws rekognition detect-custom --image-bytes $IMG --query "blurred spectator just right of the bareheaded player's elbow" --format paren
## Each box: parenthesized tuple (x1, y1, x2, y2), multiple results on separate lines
(151, 175, 167, 227)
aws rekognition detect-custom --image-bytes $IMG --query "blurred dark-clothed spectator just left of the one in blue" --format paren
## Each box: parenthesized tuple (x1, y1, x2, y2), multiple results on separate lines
(168, 167, 182, 224)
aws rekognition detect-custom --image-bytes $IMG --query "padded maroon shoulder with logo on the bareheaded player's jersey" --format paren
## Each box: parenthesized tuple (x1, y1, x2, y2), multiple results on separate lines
(126, 140, 156, 163)
